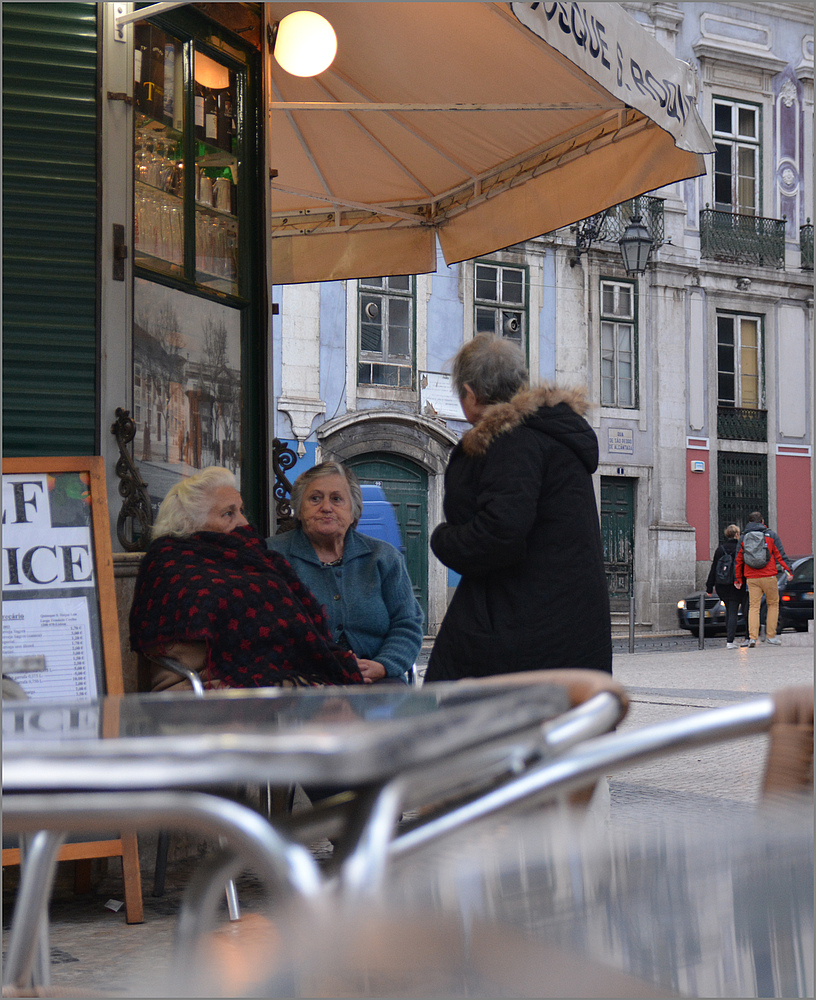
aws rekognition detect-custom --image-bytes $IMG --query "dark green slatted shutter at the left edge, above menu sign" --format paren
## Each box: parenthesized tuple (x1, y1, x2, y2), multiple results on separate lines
(2, 3, 98, 455)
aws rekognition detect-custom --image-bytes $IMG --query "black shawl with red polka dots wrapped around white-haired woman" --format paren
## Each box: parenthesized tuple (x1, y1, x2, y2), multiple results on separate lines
(130, 526, 362, 688)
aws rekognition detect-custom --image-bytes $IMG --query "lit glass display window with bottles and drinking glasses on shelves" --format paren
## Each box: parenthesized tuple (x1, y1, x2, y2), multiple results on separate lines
(133, 21, 242, 295)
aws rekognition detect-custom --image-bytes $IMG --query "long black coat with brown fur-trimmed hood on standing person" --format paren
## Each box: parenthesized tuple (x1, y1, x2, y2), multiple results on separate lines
(425, 385, 612, 681)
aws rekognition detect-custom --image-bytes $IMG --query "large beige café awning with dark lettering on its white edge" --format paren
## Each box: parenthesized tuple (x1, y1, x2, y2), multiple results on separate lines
(265, 3, 713, 284)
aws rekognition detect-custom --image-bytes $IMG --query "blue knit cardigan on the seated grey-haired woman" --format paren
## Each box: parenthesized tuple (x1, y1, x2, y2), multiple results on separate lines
(267, 528, 423, 680)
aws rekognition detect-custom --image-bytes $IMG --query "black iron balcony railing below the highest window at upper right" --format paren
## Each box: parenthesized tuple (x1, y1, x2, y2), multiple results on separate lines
(700, 208, 785, 267)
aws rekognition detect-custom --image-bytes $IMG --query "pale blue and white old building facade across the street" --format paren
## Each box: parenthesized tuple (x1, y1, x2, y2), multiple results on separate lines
(270, 3, 813, 634)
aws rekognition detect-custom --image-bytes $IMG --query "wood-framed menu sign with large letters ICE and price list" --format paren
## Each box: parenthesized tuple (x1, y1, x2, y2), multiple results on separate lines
(3, 457, 124, 701)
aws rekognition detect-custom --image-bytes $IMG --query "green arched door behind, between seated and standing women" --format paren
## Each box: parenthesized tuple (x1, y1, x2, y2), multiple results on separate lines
(345, 452, 428, 622)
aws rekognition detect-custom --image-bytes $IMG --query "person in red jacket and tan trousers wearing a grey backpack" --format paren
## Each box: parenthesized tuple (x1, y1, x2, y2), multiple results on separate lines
(734, 510, 793, 648)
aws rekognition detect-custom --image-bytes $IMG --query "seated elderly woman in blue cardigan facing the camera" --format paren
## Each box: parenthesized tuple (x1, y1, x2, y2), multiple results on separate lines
(267, 462, 423, 684)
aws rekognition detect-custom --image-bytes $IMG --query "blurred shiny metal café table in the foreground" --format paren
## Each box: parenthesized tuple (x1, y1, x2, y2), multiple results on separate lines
(3, 671, 625, 986)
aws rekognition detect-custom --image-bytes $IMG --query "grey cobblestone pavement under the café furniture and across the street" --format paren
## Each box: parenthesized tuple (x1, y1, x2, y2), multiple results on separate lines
(3, 633, 813, 997)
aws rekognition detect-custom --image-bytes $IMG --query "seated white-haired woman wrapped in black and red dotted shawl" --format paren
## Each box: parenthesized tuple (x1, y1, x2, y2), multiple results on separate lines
(130, 466, 363, 691)
